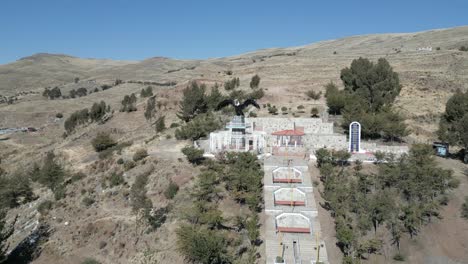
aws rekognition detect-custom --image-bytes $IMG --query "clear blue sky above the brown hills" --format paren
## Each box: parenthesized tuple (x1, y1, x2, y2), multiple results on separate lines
(0, 0, 468, 64)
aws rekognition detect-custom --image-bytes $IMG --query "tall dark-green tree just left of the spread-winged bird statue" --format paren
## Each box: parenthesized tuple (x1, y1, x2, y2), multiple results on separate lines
(177, 82, 208, 122)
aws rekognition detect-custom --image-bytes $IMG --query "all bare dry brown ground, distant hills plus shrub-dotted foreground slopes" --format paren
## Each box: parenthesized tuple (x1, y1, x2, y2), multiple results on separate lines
(0, 26, 468, 263)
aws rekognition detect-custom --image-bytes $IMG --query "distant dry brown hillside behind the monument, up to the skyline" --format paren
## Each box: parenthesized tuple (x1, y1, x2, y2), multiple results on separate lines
(0, 27, 468, 140)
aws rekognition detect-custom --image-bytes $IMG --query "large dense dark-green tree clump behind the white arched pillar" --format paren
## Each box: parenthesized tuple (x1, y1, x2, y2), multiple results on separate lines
(325, 58, 408, 140)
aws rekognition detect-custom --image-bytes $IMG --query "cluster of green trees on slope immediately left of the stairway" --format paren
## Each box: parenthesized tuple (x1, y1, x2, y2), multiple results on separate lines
(176, 150, 263, 263)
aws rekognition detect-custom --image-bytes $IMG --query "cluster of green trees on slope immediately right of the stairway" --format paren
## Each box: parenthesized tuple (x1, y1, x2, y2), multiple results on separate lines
(317, 144, 459, 263)
